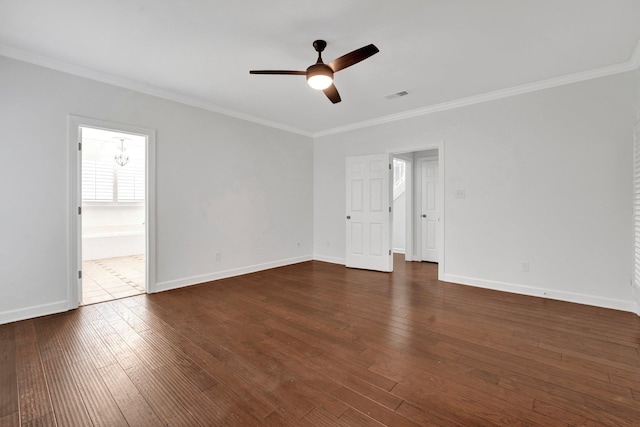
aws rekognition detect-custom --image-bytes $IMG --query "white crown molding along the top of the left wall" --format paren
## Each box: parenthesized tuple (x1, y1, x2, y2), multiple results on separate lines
(0, 43, 313, 138)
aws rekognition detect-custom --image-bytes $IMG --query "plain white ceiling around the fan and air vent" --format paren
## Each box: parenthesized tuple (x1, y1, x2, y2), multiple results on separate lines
(0, 0, 640, 135)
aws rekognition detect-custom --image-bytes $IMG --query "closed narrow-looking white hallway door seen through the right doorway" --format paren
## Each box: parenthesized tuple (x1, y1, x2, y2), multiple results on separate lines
(420, 160, 440, 262)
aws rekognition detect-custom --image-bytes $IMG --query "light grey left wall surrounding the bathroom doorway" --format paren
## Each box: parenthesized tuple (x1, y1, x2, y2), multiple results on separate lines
(0, 57, 313, 323)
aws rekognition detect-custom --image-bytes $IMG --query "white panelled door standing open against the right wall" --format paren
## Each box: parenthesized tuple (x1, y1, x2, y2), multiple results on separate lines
(345, 154, 393, 271)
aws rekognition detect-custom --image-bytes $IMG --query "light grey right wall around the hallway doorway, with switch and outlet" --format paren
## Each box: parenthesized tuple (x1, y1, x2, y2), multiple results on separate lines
(314, 73, 637, 311)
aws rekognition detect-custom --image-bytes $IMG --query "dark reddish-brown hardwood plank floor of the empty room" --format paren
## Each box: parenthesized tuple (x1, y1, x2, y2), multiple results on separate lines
(0, 258, 640, 426)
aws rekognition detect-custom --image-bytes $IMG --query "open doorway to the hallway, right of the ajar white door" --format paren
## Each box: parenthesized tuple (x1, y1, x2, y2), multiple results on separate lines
(392, 144, 444, 276)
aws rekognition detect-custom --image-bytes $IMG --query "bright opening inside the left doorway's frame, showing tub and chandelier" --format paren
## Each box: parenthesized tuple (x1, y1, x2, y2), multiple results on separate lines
(79, 126, 147, 305)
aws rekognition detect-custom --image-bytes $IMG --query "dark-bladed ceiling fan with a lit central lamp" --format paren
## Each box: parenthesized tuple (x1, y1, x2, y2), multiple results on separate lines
(249, 40, 379, 104)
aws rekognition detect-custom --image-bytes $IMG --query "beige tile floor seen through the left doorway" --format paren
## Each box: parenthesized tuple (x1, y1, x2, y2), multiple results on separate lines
(80, 255, 145, 305)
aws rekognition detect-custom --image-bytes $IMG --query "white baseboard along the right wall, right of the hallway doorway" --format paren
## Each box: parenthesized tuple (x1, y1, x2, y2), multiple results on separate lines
(440, 274, 638, 313)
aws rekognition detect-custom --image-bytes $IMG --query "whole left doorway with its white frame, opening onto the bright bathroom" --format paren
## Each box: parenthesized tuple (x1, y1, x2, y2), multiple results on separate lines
(67, 115, 156, 309)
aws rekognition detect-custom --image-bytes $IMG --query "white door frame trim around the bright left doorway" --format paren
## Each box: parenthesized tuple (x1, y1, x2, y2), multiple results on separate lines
(67, 115, 156, 310)
